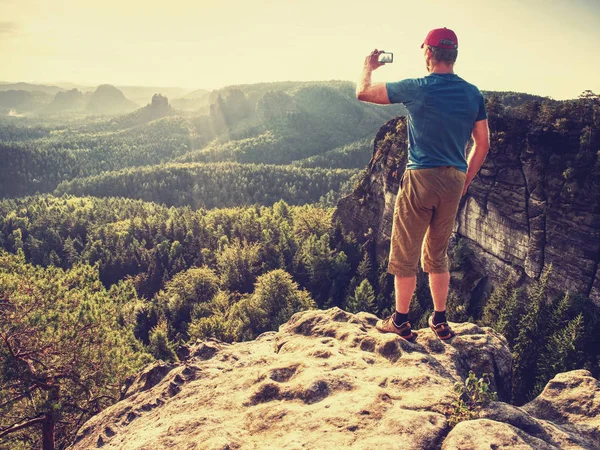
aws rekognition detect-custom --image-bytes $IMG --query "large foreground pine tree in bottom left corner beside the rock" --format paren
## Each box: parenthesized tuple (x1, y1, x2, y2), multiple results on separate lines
(0, 251, 151, 450)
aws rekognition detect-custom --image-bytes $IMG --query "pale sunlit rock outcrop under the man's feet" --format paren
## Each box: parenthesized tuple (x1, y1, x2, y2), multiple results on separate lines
(73, 307, 600, 450)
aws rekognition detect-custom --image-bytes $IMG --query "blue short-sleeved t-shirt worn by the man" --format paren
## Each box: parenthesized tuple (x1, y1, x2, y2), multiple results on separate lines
(386, 73, 487, 172)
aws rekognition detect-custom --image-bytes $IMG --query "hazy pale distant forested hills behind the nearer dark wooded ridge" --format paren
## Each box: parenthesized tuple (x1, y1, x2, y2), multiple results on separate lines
(0, 82, 403, 204)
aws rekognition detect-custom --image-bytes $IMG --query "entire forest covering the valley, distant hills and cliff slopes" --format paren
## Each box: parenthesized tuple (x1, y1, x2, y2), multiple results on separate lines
(0, 82, 600, 449)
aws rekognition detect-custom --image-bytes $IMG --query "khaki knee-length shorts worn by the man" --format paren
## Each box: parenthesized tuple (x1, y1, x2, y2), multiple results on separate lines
(388, 166, 467, 277)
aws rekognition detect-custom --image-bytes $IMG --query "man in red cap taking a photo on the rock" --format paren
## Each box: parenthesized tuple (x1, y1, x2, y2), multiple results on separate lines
(356, 28, 489, 341)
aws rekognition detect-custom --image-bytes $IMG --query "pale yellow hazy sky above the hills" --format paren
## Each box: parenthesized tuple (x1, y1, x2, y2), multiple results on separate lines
(0, 0, 600, 99)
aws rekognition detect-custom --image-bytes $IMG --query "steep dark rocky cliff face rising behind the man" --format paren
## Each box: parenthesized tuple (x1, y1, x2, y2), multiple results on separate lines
(336, 118, 600, 303)
